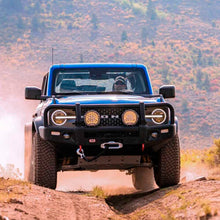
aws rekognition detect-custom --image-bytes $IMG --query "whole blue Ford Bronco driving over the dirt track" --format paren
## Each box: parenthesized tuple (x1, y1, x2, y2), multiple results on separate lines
(25, 63, 180, 190)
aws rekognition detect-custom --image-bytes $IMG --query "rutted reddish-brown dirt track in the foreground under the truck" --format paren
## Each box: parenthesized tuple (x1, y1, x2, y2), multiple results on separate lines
(0, 178, 220, 220)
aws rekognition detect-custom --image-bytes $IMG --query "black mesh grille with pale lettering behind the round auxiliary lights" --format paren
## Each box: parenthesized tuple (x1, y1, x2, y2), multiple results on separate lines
(81, 106, 140, 127)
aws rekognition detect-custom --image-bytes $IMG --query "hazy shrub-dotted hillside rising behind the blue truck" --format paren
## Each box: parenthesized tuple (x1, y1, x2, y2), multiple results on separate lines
(0, 0, 220, 148)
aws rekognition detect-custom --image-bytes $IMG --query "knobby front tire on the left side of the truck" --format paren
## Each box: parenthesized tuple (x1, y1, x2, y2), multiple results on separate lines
(29, 133, 57, 189)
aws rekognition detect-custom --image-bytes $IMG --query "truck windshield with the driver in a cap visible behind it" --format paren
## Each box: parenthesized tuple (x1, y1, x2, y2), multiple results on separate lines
(53, 68, 149, 94)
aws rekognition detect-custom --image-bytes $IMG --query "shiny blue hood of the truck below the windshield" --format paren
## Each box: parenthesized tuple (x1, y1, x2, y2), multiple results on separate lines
(52, 94, 161, 105)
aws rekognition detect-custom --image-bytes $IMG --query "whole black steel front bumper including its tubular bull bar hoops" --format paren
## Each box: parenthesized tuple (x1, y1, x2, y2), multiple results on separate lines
(39, 102, 177, 154)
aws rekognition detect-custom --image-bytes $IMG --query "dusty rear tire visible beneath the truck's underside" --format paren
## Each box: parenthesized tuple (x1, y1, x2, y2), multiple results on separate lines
(132, 167, 155, 191)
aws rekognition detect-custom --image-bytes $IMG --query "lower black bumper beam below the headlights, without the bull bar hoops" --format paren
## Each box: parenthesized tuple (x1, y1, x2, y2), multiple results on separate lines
(39, 124, 176, 147)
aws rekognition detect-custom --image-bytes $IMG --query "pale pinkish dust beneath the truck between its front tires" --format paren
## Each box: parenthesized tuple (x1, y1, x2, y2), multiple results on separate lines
(57, 170, 135, 194)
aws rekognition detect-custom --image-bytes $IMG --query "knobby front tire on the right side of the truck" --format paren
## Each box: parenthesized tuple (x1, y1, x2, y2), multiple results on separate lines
(154, 135, 180, 188)
